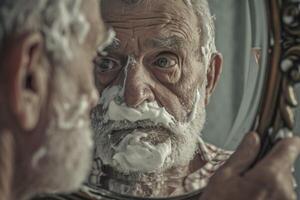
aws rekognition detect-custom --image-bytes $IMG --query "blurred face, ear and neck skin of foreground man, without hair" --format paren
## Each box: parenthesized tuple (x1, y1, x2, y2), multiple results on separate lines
(0, 0, 106, 199)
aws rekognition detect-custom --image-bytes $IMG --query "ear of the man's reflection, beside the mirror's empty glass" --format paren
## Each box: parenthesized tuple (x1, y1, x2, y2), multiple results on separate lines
(205, 53, 223, 105)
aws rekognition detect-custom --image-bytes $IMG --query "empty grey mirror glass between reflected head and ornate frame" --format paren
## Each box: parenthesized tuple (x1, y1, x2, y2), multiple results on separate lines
(203, 0, 268, 150)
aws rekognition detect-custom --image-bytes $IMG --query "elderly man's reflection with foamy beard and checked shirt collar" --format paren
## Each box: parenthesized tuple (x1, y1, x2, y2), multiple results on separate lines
(89, 0, 230, 196)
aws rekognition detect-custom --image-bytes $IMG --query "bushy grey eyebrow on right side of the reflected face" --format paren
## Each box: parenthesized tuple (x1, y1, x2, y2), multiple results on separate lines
(146, 35, 186, 51)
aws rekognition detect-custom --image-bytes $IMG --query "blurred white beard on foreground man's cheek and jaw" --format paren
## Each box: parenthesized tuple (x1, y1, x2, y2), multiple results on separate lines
(19, 67, 93, 197)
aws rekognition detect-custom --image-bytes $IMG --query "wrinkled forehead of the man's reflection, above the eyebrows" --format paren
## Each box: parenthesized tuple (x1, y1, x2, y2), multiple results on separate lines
(102, 0, 198, 43)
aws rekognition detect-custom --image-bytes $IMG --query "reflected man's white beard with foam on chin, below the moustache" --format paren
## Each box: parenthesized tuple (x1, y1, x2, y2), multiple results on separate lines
(91, 86, 205, 178)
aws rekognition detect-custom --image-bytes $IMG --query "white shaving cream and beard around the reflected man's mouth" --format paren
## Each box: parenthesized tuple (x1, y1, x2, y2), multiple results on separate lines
(92, 80, 205, 173)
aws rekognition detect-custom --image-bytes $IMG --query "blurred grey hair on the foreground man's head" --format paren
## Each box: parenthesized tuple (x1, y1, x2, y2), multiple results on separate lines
(0, 0, 90, 62)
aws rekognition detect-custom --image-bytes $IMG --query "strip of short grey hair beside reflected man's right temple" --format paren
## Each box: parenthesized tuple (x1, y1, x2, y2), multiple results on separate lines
(184, 0, 217, 66)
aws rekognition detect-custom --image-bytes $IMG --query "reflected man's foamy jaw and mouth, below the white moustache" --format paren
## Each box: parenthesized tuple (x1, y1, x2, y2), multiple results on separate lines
(90, 117, 198, 177)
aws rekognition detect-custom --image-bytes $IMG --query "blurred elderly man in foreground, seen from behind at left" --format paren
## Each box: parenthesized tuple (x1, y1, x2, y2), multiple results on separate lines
(0, 0, 110, 200)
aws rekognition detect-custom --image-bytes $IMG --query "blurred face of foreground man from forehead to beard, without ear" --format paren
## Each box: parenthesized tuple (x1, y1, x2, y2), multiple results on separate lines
(14, 0, 107, 193)
